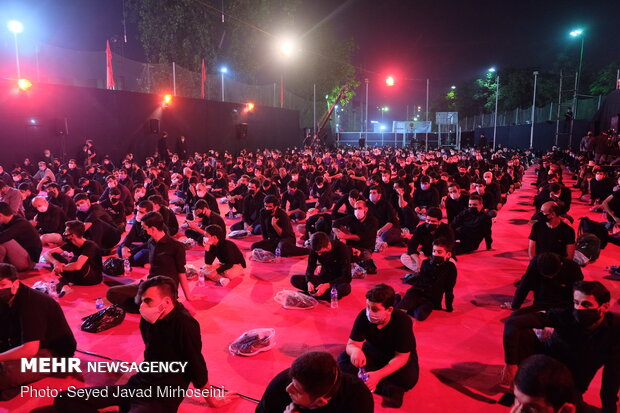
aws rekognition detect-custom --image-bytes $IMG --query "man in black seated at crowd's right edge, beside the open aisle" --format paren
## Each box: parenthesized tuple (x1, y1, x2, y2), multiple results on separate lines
(451, 194, 493, 254)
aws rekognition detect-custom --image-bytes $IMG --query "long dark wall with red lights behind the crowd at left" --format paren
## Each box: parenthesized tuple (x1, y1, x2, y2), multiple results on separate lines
(0, 80, 302, 169)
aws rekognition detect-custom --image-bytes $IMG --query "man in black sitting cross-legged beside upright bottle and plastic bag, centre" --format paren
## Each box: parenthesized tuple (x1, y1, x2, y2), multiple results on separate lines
(291, 232, 351, 301)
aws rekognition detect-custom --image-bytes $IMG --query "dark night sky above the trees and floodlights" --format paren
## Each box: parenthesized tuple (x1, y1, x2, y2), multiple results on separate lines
(0, 0, 620, 121)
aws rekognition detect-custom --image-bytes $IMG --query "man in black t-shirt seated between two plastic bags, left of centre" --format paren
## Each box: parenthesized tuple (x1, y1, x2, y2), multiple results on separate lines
(203, 225, 246, 287)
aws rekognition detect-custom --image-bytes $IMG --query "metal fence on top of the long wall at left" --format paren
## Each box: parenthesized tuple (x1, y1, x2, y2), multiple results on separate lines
(0, 45, 312, 124)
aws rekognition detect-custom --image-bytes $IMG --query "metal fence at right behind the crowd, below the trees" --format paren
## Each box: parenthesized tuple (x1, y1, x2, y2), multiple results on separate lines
(459, 96, 603, 131)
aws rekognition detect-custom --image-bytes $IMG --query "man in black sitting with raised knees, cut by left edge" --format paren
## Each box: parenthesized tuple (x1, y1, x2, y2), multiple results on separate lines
(0, 202, 43, 271)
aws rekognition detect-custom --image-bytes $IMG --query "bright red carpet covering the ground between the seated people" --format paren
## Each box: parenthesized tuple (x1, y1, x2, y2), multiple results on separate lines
(0, 168, 620, 413)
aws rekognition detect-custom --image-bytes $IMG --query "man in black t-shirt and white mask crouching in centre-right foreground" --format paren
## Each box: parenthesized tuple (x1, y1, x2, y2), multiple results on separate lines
(338, 284, 420, 408)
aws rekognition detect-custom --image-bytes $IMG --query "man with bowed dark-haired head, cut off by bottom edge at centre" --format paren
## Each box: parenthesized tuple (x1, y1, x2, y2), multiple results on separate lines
(256, 351, 374, 413)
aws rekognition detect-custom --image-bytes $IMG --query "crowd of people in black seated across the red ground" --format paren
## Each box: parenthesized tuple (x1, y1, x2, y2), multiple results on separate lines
(0, 138, 620, 412)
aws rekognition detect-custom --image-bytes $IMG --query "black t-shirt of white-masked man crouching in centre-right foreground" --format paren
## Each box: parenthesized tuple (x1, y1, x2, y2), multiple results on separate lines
(350, 309, 418, 364)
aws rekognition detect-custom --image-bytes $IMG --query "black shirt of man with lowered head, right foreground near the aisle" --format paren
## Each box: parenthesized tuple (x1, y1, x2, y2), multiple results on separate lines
(512, 257, 583, 309)
